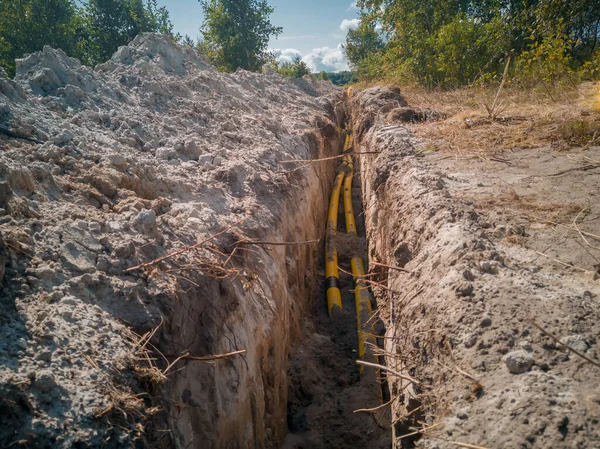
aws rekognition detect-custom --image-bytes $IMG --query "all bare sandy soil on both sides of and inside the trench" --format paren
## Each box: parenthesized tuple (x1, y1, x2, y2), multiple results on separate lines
(0, 30, 600, 449)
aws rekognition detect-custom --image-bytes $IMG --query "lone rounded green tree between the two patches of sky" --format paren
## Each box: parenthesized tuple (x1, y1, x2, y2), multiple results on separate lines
(200, 0, 282, 72)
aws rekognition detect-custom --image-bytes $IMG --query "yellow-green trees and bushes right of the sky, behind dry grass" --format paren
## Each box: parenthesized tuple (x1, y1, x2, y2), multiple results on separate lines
(345, 0, 600, 88)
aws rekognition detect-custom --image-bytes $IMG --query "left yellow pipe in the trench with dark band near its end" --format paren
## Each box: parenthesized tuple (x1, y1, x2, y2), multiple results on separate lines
(325, 171, 345, 317)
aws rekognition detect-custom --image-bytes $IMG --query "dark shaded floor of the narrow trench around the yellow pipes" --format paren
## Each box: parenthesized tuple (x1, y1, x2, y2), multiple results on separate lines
(283, 118, 391, 449)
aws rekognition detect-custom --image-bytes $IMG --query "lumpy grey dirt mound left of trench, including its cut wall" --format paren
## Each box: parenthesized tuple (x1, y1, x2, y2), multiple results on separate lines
(0, 34, 342, 448)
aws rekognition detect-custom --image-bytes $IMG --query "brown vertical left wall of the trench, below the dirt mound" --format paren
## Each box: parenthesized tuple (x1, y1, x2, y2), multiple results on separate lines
(163, 109, 344, 448)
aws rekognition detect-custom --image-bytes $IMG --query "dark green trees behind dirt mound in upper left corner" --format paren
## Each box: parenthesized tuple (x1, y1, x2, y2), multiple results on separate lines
(0, 0, 175, 76)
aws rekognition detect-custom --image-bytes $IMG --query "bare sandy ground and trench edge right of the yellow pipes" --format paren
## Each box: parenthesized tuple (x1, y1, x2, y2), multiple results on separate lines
(352, 88, 600, 448)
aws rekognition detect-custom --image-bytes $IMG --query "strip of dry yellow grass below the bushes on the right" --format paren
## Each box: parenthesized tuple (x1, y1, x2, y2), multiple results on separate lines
(403, 82, 600, 154)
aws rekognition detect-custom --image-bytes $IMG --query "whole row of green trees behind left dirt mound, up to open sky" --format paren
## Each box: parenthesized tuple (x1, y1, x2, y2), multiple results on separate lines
(0, 0, 296, 76)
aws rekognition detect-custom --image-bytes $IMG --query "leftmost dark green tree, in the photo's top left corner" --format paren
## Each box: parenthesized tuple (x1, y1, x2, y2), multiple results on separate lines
(0, 0, 78, 76)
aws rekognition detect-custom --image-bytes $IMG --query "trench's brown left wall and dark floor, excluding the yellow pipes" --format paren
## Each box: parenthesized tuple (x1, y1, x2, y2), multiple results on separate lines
(159, 94, 391, 449)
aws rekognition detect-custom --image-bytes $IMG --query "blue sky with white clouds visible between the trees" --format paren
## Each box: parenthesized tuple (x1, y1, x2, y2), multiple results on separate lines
(159, 0, 358, 72)
